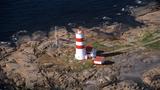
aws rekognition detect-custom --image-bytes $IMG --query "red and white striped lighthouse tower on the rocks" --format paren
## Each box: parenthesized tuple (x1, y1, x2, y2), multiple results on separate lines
(75, 30, 86, 60)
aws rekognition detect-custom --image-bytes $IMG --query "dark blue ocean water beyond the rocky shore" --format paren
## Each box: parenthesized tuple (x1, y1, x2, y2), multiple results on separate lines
(0, 0, 154, 41)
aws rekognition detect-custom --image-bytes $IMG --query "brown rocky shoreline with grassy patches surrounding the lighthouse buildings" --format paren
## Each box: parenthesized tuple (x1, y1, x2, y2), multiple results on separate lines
(0, 5, 160, 90)
